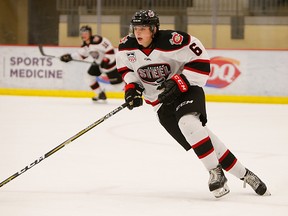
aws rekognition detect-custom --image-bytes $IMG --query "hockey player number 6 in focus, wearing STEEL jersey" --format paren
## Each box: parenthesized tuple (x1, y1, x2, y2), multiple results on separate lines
(116, 10, 270, 198)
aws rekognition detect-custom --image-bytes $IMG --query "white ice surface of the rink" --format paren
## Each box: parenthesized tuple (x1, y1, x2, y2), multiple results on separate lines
(0, 96, 288, 216)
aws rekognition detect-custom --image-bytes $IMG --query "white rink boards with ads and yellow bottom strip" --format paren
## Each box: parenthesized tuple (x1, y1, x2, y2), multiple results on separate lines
(0, 46, 288, 103)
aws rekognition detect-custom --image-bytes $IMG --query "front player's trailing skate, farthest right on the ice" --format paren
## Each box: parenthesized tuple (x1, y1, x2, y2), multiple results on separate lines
(241, 168, 271, 196)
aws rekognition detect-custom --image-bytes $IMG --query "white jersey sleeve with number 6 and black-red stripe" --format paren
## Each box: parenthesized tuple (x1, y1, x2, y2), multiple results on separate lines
(180, 36, 210, 87)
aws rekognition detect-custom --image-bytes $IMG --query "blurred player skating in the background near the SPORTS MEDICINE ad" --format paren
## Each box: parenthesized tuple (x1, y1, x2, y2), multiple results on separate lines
(60, 25, 122, 101)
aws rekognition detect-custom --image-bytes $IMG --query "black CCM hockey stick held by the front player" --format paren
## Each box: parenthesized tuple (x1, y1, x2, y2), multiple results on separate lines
(0, 103, 128, 187)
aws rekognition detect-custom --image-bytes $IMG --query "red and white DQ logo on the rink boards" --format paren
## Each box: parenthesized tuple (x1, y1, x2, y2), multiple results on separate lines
(206, 57, 241, 88)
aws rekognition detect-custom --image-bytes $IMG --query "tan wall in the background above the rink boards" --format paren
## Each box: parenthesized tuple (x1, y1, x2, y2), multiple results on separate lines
(59, 15, 288, 49)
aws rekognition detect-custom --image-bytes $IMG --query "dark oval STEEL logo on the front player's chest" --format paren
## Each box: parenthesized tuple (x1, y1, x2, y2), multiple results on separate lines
(137, 64, 171, 86)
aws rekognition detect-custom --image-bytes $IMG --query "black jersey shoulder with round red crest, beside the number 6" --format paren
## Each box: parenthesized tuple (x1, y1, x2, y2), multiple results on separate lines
(156, 30, 190, 51)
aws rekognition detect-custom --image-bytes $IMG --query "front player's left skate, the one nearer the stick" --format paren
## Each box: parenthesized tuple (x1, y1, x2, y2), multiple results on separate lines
(208, 164, 230, 198)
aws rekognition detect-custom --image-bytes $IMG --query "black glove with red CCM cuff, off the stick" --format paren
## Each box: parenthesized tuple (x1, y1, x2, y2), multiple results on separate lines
(157, 74, 190, 104)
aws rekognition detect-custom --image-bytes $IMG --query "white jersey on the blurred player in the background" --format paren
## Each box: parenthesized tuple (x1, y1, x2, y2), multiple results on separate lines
(71, 35, 116, 73)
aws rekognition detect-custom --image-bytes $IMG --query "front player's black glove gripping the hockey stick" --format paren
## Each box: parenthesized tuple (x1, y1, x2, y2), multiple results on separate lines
(125, 83, 144, 110)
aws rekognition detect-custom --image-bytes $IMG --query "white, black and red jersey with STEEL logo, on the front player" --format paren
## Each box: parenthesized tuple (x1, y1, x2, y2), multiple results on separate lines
(116, 30, 210, 106)
